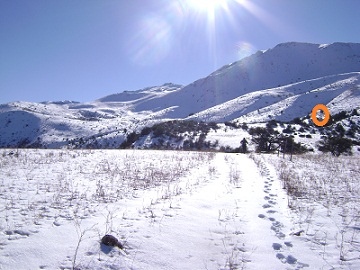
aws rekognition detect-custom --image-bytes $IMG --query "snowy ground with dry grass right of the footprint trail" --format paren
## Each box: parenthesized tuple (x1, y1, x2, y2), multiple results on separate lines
(268, 155, 360, 269)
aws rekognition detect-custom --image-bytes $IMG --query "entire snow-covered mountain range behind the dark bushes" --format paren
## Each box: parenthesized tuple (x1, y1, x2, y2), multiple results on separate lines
(0, 42, 360, 147)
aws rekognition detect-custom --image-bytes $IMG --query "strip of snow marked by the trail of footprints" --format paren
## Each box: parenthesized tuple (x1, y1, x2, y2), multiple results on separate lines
(244, 157, 323, 269)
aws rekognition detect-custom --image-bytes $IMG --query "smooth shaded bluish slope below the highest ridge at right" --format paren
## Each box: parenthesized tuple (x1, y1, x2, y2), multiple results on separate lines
(111, 43, 360, 120)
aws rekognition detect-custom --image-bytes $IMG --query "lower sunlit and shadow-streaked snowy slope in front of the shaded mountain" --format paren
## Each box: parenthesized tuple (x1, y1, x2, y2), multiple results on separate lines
(187, 72, 360, 123)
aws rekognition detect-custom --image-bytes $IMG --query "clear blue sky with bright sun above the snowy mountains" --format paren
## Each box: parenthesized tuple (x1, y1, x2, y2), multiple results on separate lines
(0, 0, 360, 103)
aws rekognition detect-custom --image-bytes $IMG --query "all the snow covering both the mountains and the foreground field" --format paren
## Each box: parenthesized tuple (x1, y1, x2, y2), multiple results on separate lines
(0, 43, 360, 270)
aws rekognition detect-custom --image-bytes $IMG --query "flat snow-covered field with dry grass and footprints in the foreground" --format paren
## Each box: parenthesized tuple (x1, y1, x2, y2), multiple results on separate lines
(0, 149, 360, 269)
